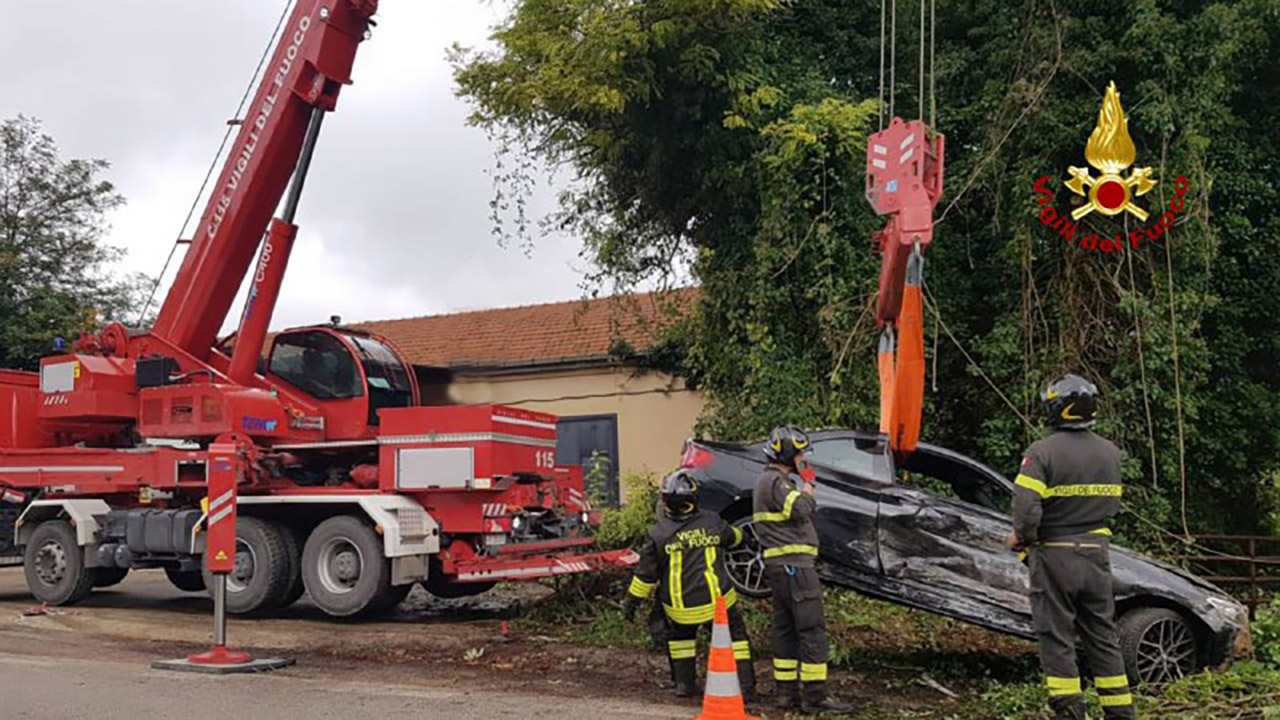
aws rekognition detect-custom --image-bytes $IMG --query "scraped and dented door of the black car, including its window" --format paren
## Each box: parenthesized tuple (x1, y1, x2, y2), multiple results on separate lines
(878, 446, 1030, 632)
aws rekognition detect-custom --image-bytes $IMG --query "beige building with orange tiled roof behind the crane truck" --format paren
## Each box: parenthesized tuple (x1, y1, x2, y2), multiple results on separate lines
(356, 288, 703, 498)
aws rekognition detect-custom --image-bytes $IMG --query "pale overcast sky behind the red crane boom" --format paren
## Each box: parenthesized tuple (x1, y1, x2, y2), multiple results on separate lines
(0, 0, 585, 327)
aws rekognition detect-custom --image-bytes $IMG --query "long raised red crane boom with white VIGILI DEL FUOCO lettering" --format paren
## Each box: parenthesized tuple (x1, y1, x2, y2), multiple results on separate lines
(152, 0, 378, 360)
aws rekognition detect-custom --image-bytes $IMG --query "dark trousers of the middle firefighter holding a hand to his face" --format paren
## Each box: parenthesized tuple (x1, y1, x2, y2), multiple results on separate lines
(768, 565, 827, 703)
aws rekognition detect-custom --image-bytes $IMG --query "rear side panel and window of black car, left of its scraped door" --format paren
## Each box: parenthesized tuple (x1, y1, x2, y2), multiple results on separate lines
(806, 434, 892, 574)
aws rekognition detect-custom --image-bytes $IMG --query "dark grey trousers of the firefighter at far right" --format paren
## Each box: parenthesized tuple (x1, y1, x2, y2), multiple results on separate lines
(1030, 536, 1135, 720)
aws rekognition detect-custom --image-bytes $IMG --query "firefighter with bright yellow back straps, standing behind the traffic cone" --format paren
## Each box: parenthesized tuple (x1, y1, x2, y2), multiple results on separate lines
(623, 470, 755, 702)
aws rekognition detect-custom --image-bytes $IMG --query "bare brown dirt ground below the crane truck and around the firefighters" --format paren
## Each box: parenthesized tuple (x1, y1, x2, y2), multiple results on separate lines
(0, 568, 1024, 719)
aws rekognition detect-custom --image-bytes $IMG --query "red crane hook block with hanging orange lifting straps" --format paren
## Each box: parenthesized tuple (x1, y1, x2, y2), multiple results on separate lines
(867, 118, 945, 455)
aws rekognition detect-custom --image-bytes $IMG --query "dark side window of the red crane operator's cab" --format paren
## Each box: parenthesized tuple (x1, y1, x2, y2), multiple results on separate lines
(268, 332, 364, 400)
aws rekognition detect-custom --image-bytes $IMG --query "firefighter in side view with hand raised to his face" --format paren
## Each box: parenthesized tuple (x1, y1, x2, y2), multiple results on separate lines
(753, 425, 852, 714)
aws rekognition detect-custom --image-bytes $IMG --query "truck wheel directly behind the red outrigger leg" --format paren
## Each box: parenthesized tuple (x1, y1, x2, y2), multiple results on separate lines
(204, 515, 291, 615)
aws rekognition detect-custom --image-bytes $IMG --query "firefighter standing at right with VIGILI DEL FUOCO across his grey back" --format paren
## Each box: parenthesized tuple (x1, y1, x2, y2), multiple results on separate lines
(1009, 375, 1135, 720)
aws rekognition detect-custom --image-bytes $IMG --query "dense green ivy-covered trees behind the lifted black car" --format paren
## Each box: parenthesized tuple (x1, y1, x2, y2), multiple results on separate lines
(454, 0, 1280, 538)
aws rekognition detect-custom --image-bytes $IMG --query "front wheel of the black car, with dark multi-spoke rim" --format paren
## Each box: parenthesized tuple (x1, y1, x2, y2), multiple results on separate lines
(1117, 607, 1199, 685)
